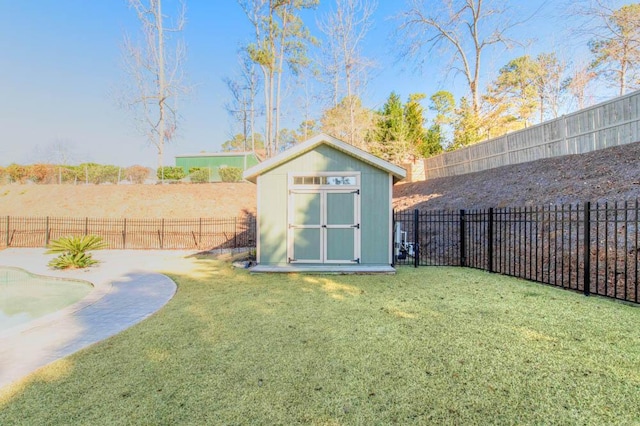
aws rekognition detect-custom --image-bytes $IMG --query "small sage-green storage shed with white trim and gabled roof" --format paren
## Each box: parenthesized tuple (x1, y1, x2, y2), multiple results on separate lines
(244, 134, 405, 272)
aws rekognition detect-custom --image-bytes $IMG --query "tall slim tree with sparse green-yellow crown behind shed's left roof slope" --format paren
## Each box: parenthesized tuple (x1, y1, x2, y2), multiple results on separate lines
(238, 0, 318, 156)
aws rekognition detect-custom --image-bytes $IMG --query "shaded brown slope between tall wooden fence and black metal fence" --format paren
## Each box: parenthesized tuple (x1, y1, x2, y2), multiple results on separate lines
(394, 142, 640, 210)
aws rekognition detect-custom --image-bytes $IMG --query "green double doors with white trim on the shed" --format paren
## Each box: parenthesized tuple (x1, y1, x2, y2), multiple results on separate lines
(288, 189, 360, 263)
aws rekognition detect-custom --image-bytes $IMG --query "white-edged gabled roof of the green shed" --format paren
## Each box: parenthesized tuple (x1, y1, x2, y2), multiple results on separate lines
(243, 133, 407, 183)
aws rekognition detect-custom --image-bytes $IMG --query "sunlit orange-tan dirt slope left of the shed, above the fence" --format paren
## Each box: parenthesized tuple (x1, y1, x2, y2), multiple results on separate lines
(0, 183, 256, 218)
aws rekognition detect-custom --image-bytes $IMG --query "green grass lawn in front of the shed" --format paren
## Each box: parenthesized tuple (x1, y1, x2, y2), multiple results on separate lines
(0, 259, 640, 425)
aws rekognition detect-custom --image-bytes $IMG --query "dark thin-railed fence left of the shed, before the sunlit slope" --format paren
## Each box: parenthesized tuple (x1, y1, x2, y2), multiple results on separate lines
(0, 216, 256, 250)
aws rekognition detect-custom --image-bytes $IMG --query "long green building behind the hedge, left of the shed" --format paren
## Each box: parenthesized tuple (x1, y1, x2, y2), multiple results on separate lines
(176, 152, 260, 182)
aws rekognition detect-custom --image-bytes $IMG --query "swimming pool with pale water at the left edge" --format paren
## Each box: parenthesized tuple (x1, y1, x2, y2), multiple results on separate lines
(0, 266, 93, 332)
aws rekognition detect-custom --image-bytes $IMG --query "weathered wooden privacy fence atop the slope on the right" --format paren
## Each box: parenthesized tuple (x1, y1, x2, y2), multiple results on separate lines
(424, 91, 640, 179)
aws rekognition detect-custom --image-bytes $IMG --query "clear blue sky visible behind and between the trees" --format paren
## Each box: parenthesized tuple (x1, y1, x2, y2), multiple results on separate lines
(0, 0, 624, 166)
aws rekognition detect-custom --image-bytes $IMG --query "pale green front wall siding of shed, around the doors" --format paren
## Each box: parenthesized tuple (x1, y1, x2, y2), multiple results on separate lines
(257, 145, 391, 265)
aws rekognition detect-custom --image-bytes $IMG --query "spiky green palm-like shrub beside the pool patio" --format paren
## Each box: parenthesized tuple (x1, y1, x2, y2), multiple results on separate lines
(47, 235, 107, 269)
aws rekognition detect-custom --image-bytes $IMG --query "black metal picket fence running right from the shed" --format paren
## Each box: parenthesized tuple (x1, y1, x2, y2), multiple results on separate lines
(394, 200, 640, 303)
